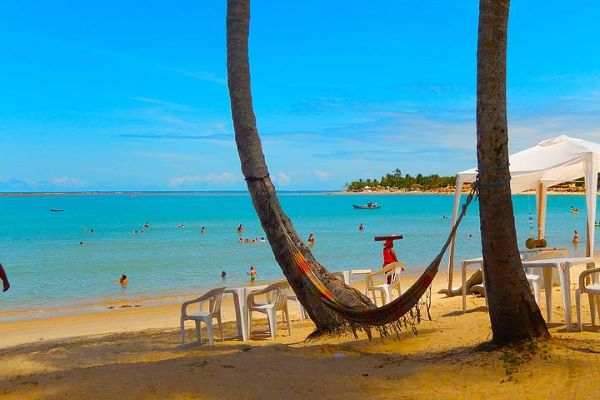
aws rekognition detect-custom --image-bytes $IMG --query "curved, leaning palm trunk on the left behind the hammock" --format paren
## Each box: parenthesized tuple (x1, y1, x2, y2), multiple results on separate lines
(227, 0, 373, 332)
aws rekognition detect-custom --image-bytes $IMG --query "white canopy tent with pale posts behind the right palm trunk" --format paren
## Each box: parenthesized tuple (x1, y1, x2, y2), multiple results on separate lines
(448, 135, 600, 282)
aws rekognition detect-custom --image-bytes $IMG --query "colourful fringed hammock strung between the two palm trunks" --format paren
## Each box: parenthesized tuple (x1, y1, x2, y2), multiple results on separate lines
(294, 182, 478, 326)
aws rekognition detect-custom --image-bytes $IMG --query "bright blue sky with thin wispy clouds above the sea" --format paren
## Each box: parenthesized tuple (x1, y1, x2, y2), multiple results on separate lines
(0, 0, 600, 191)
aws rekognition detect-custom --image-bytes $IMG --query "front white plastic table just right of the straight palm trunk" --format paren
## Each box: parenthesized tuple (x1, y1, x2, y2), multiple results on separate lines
(523, 257, 594, 331)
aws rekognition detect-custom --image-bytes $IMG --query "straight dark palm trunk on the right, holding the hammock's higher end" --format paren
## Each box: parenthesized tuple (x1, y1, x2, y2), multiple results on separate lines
(477, 0, 549, 344)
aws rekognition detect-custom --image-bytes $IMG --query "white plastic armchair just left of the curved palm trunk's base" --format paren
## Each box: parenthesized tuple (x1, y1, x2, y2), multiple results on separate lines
(248, 281, 292, 339)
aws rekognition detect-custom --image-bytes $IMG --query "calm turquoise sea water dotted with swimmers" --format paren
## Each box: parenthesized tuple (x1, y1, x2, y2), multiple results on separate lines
(0, 193, 586, 312)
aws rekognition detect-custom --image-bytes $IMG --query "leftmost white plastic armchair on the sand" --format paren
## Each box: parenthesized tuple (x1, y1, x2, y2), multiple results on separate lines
(180, 287, 225, 346)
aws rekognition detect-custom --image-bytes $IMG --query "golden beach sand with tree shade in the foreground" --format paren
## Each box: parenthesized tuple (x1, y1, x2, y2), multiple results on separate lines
(0, 276, 600, 400)
